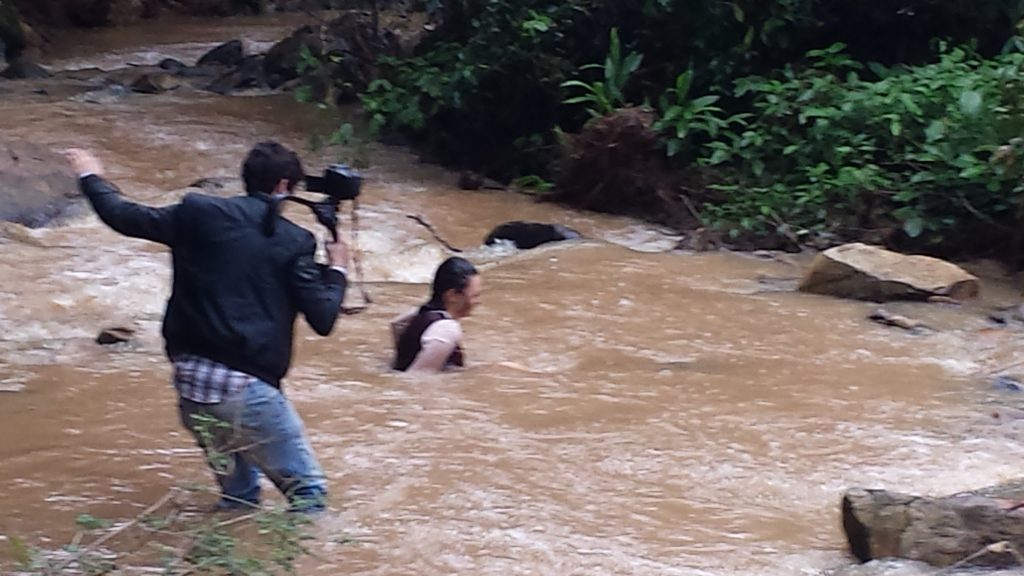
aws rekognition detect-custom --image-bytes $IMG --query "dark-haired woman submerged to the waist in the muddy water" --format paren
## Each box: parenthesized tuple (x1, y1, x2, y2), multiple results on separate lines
(391, 256, 482, 372)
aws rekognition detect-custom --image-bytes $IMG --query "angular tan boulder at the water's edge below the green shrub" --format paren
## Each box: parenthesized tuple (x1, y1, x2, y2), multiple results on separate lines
(800, 243, 980, 302)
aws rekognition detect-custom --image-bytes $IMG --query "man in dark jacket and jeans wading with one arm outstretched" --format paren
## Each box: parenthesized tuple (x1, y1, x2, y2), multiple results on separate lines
(68, 142, 348, 511)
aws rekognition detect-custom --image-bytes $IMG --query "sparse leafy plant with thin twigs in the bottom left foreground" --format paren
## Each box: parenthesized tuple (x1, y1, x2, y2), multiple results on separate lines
(7, 417, 351, 576)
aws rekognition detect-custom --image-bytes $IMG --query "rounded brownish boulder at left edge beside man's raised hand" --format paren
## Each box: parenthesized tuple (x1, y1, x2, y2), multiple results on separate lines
(0, 140, 79, 227)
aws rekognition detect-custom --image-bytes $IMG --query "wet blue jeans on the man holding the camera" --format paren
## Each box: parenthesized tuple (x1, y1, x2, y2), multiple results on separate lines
(178, 380, 327, 511)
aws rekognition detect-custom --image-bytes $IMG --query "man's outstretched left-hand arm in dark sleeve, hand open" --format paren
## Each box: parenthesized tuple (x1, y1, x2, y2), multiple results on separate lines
(66, 149, 177, 246)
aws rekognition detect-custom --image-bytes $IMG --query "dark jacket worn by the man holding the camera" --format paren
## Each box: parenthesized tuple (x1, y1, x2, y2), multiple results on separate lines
(80, 175, 346, 386)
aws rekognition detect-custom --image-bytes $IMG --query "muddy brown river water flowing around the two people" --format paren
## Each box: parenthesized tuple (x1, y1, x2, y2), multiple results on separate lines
(0, 16, 1024, 576)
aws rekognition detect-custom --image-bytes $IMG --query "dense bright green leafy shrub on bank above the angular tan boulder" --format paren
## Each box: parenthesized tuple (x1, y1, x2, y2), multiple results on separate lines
(701, 45, 1024, 251)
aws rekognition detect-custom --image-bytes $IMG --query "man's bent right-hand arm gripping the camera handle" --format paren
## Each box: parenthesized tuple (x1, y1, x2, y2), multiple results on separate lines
(292, 236, 348, 336)
